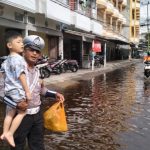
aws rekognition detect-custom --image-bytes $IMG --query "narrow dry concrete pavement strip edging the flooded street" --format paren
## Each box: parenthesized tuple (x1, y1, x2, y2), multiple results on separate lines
(44, 59, 142, 85)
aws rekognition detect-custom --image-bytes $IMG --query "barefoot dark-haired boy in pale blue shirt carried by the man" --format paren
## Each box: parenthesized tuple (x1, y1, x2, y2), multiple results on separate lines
(0, 31, 31, 147)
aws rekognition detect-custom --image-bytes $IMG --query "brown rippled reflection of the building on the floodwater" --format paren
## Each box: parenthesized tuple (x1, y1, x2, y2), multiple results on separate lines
(45, 65, 139, 150)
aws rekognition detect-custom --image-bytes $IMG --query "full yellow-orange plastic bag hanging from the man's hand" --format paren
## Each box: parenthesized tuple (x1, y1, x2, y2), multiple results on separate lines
(43, 102, 68, 132)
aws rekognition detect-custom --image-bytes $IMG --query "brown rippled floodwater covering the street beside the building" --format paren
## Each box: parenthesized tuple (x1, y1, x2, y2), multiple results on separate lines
(0, 63, 150, 150)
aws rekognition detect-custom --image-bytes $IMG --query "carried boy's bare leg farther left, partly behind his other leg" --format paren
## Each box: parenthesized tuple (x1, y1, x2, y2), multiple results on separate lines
(0, 106, 16, 140)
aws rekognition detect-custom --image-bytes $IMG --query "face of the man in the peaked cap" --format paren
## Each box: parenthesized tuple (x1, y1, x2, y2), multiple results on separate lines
(24, 47, 41, 64)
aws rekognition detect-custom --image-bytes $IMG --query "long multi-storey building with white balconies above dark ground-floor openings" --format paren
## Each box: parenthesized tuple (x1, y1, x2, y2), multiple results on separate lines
(0, 0, 138, 67)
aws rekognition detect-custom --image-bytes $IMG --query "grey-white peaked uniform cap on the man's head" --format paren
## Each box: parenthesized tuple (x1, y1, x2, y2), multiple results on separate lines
(23, 35, 45, 51)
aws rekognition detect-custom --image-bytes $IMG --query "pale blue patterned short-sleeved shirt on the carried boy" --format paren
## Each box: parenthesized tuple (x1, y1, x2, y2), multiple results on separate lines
(2, 54, 29, 102)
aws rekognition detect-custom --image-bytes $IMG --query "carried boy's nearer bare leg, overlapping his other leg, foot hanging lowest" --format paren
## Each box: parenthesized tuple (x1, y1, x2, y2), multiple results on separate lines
(5, 111, 26, 147)
